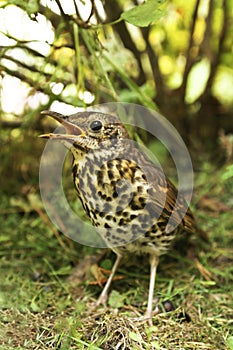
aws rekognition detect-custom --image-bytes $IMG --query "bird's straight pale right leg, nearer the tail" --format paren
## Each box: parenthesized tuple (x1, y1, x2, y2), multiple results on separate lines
(144, 255, 159, 326)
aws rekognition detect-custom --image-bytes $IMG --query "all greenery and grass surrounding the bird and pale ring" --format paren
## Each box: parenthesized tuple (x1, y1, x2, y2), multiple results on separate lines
(0, 0, 233, 350)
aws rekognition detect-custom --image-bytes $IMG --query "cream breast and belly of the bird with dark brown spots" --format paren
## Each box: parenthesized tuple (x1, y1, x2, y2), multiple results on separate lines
(75, 161, 177, 255)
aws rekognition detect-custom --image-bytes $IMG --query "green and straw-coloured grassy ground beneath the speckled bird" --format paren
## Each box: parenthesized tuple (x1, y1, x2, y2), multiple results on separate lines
(0, 164, 233, 350)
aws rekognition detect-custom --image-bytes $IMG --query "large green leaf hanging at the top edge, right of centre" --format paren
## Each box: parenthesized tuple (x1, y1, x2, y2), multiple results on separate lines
(121, 0, 166, 27)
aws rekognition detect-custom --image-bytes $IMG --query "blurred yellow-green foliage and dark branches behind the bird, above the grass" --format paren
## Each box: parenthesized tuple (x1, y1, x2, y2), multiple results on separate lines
(0, 0, 233, 193)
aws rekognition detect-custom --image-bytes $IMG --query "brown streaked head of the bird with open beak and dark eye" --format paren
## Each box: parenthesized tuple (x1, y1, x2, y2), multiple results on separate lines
(40, 111, 129, 151)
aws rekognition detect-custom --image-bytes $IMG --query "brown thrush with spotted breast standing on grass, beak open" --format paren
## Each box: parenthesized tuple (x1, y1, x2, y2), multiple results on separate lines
(41, 111, 196, 324)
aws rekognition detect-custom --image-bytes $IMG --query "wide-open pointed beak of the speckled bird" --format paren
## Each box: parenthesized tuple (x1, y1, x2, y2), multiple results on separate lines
(39, 111, 85, 143)
